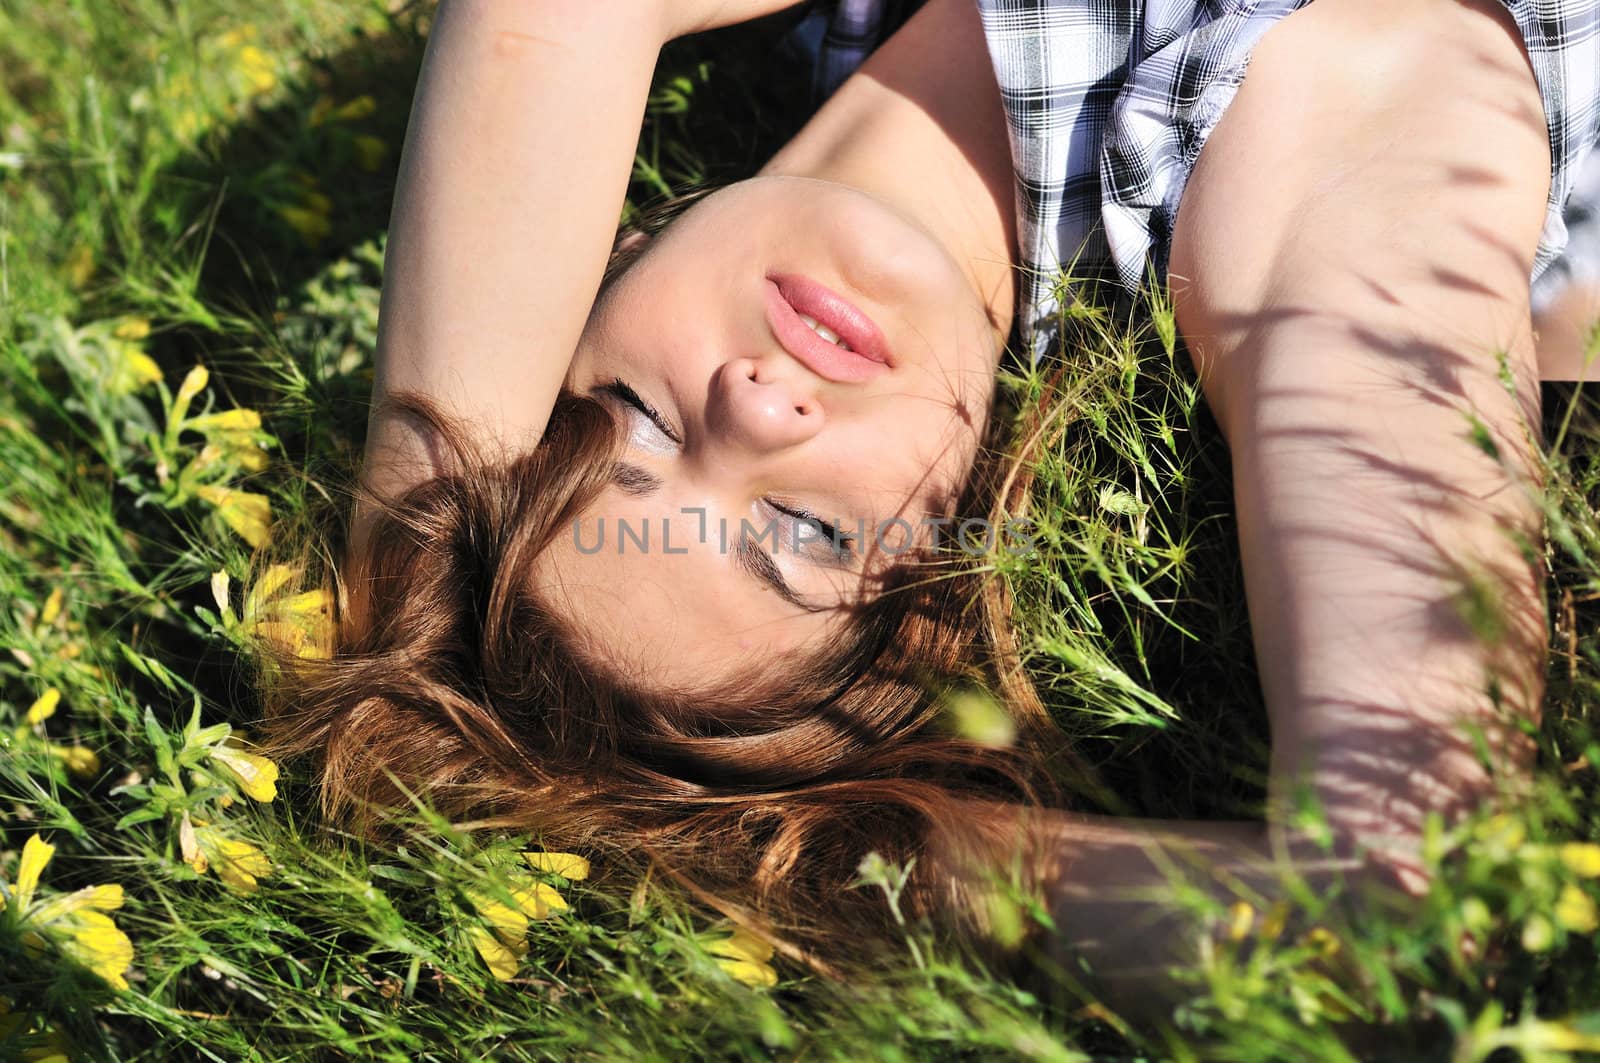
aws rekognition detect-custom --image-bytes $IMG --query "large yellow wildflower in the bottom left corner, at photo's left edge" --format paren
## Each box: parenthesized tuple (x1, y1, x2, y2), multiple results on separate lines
(0, 834, 133, 989)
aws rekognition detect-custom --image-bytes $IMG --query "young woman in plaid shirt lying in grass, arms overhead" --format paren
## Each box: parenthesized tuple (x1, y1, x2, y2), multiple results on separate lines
(256, 0, 1597, 998)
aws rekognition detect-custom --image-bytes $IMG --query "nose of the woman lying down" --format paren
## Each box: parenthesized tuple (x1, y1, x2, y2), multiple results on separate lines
(707, 357, 824, 451)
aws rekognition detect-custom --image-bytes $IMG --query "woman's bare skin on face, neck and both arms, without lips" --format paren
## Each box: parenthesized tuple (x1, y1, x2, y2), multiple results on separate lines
(366, 0, 1574, 1001)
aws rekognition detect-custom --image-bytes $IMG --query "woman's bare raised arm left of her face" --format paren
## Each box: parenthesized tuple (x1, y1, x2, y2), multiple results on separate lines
(364, 0, 806, 540)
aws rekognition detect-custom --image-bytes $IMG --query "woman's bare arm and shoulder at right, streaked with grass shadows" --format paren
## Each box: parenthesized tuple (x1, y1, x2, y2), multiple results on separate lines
(1171, 0, 1549, 887)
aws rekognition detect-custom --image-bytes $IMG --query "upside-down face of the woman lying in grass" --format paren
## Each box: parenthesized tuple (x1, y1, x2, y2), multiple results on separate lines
(539, 176, 1000, 690)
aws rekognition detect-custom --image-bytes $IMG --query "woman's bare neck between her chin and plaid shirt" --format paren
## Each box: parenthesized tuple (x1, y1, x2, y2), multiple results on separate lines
(762, 0, 1016, 359)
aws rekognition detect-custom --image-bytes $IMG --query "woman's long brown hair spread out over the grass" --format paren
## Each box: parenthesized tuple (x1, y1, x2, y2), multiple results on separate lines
(264, 203, 1054, 956)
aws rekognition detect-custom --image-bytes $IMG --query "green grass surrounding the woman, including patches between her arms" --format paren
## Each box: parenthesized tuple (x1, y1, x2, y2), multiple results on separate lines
(9, 0, 1600, 1060)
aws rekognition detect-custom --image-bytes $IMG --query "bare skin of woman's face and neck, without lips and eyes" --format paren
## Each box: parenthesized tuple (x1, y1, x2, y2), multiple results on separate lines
(538, 5, 1016, 688)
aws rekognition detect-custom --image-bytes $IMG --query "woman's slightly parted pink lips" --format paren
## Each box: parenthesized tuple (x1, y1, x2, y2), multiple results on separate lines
(766, 274, 894, 384)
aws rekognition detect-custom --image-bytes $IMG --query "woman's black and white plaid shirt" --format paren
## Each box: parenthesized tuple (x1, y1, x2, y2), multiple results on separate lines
(806, 0, 1600, 357)
